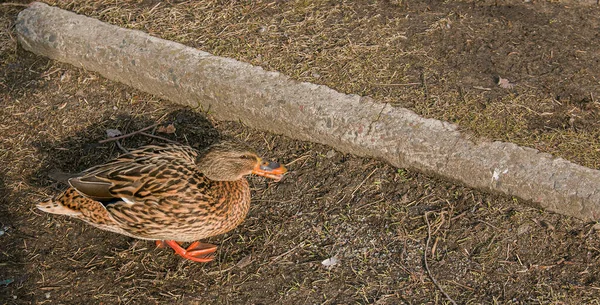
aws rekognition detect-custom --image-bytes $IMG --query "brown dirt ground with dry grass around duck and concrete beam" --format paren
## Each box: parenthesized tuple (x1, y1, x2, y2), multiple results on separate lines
(0, 0, 600, 304)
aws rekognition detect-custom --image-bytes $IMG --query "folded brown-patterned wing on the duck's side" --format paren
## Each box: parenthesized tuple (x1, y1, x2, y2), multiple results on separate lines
(69, 145, 197, 204)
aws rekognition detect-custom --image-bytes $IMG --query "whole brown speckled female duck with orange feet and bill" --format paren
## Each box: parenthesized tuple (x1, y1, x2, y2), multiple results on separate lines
(37, 142, 286, 262)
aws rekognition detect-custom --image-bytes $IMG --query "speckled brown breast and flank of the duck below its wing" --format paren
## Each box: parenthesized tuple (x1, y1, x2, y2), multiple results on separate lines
(106, 174, 250, 241)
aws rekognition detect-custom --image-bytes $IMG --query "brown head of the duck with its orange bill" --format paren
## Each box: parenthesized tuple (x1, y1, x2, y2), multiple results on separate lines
(198, 141, 287, 181)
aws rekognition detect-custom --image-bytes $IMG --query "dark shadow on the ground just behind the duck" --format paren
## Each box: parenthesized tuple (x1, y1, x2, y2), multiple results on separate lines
(30, 109, 220, 186)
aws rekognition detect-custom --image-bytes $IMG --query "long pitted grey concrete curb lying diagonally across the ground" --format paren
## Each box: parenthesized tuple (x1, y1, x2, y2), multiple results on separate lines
(17, 3, 600, 221)
